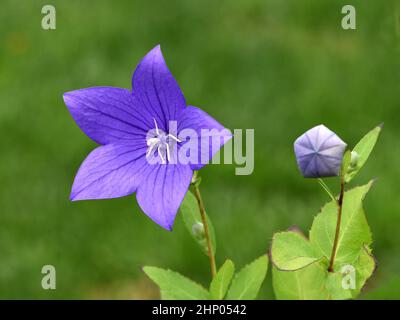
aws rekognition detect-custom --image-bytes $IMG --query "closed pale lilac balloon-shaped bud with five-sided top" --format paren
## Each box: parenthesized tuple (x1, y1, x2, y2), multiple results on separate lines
(294, 124, 347, 178)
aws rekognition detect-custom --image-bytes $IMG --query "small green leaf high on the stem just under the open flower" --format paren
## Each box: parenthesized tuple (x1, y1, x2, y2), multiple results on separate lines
(180, 191, 216, 255)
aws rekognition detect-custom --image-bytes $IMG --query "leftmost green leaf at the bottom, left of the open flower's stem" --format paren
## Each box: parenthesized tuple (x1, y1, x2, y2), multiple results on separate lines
(143, 267, 209, 300)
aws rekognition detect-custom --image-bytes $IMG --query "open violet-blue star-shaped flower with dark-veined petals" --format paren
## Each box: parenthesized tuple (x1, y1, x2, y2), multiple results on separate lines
(64, 46, 231, 230)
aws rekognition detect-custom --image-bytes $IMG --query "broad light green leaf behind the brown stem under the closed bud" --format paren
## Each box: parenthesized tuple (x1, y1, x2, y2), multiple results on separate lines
(310, 181, 373, 271)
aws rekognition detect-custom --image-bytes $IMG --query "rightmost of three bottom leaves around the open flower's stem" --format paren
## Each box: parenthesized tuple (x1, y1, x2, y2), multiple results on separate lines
(227, 255, 268, 300)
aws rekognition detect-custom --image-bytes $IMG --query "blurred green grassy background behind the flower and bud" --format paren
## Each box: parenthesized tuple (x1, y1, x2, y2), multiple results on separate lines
(0, 0, 400, 299)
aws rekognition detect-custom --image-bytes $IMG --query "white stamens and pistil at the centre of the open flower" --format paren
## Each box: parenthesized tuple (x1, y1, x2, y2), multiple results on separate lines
(146, 119, 181, 164)
